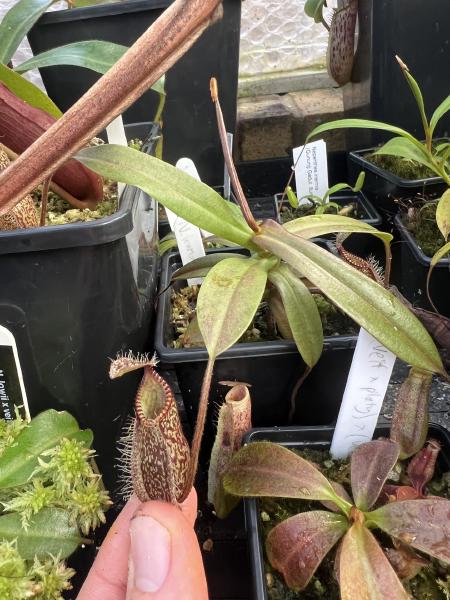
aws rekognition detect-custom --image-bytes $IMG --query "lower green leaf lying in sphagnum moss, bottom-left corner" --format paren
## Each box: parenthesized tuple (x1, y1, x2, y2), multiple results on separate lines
(0, 508, 86, 560)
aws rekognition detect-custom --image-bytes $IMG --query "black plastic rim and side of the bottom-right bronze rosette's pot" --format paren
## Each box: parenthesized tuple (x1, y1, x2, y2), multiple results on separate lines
(244, 425, 450, 600)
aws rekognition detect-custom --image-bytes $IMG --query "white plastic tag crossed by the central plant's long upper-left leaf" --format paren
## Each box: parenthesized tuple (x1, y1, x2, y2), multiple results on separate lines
(166, 158, 205, 285)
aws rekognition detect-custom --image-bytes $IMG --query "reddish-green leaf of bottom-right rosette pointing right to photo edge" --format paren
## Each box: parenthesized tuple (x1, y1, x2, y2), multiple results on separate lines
(367, 498, 450, 563)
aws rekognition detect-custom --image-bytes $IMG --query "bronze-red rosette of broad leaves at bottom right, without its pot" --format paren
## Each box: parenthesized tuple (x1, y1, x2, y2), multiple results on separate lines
(223, 440, 450, 600)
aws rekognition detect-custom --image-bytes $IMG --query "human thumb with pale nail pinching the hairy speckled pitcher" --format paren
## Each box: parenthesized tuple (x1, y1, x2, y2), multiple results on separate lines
(126, 494, 208, 600)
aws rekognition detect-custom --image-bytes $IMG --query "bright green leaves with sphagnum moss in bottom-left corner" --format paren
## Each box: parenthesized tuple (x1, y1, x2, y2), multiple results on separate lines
(0, 410, 111, 600)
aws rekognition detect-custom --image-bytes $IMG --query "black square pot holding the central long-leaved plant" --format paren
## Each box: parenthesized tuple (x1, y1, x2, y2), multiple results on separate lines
(155, 247, 356, 446)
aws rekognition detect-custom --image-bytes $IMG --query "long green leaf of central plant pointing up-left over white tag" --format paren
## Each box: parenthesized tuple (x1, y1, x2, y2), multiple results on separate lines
(75, 144, 252, 246)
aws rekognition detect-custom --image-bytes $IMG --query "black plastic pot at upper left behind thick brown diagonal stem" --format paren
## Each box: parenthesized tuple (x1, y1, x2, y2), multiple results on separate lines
(28, 0, 241, 185)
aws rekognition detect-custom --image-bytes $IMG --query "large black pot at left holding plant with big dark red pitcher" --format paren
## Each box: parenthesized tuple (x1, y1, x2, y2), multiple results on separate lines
(0, 0, 165, 489)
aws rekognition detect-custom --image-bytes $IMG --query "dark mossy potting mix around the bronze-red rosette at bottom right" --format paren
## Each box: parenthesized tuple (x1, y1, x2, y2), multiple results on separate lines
(259, 450, 450, 600)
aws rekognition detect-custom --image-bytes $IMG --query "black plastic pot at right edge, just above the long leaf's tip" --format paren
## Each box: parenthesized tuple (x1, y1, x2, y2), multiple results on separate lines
(395, 214, 450, 317)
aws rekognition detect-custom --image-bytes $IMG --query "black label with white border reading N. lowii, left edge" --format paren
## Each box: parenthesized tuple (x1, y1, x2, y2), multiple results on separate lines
(0, 325, 30, 421)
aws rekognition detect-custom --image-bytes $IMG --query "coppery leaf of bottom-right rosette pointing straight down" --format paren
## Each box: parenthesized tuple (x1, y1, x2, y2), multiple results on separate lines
(338, 523, 409, 600)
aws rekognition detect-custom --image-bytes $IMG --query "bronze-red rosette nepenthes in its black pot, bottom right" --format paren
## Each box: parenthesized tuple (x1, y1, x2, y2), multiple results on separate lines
(223, 426, 450, 600)
